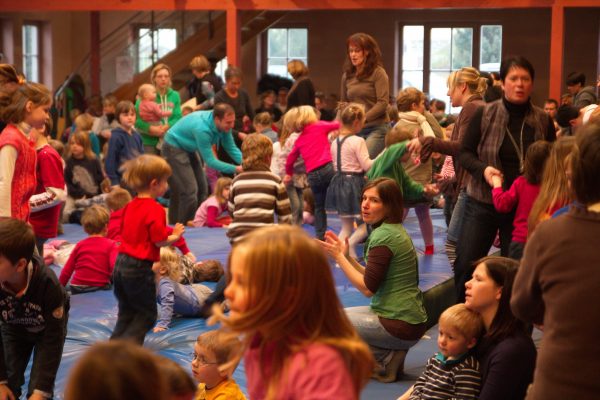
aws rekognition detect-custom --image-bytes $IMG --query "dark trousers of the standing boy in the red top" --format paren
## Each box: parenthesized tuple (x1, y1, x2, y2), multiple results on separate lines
(110, 254, 157, 345)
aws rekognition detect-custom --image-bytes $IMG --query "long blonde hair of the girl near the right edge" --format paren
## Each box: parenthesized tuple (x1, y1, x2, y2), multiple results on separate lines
(527, 136, 575, 235)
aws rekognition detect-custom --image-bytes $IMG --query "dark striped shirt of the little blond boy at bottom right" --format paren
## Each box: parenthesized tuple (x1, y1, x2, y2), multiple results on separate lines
(410, 354, 481, 400)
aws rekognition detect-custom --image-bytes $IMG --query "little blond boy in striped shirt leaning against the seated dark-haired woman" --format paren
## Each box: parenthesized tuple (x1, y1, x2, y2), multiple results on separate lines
(398, 303, 483, 400)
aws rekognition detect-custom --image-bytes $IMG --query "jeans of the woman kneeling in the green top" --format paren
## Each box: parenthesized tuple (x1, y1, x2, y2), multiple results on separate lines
(345, 306, 418, 364)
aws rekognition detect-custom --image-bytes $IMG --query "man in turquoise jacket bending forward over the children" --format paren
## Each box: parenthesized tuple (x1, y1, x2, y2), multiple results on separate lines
(162, 103, 242, 224)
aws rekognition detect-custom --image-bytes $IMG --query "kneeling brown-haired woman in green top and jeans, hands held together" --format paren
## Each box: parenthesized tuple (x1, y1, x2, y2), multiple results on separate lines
(321, 178, 427, 382)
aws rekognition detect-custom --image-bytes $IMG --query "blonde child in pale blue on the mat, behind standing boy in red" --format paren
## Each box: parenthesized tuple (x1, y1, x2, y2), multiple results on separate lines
(152, 247, 212, 332)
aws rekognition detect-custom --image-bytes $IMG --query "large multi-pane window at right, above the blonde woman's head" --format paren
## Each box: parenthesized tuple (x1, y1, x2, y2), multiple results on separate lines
(398, 25, 502, 112)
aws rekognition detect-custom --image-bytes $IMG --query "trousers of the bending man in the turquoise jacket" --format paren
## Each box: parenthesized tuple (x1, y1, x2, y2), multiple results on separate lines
(162, 143, 208, 224)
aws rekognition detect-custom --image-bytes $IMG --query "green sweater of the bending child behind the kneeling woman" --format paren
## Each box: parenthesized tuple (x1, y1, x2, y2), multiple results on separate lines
(367, 141, 423, 201)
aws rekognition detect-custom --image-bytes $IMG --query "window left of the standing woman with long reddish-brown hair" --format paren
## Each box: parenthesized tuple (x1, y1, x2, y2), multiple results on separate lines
(267, 28, 308, 78)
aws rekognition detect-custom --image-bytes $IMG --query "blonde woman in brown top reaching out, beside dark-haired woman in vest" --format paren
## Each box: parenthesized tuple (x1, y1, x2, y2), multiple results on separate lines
(408, 67, 487, 266)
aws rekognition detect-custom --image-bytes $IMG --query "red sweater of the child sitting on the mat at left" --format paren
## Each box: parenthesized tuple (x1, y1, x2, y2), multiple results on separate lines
(58, 236, 118, 287)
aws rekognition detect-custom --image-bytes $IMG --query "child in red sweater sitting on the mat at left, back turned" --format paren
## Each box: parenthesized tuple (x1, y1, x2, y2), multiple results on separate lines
(59, 205, 118, 294)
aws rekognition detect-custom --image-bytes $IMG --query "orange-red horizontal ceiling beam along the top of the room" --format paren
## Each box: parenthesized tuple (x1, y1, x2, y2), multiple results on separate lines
(0, 0, 600, 12)
